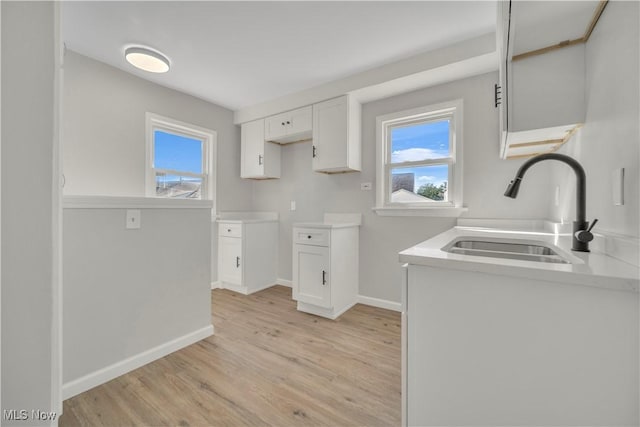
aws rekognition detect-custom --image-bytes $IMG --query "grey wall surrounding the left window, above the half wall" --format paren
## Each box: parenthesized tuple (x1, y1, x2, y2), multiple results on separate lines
(62, 51, 251, 280)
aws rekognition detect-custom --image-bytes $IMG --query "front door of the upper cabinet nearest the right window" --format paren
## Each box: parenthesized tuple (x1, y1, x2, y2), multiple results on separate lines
(313, 97, 349, 172)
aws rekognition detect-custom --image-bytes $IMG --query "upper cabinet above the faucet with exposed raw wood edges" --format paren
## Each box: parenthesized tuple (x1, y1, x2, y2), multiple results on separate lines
(496, 1, 600, 158)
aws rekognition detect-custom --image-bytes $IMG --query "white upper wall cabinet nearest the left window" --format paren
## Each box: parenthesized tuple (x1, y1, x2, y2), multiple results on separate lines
(240, 119, 280, 179)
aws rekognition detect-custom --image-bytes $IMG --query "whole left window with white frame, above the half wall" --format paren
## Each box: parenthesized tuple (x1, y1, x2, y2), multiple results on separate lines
(146, 113, 216, 200)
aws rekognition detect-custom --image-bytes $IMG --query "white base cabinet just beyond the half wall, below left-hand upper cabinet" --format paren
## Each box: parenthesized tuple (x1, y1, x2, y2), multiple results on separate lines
(218, 220, 278, 295)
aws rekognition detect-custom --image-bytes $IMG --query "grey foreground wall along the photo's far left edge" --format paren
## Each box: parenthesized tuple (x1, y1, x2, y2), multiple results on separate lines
(0, 2, 58, 426)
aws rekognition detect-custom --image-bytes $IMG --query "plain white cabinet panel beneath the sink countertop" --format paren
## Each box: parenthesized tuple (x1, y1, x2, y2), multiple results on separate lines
(402, 266, 638, 426)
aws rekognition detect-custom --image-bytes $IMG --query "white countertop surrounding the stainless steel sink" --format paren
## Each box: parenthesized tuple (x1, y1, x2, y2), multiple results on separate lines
(399, 226, 640, 292)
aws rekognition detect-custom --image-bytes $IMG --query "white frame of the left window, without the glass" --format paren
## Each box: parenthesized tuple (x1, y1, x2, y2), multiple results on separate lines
(145, 112, 217, 205)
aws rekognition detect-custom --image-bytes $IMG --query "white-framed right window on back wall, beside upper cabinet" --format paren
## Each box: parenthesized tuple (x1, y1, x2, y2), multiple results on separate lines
(376, 100, 462, 214)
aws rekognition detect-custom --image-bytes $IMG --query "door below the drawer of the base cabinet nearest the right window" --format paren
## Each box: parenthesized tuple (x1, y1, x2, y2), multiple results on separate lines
(293, 245, 331, 308)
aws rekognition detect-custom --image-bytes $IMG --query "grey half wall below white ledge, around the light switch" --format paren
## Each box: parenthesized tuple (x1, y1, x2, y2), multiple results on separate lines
(63, 209, 211, 396)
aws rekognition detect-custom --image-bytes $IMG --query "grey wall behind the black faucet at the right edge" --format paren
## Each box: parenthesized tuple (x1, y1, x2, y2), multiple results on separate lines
(549, 1, 640, 237)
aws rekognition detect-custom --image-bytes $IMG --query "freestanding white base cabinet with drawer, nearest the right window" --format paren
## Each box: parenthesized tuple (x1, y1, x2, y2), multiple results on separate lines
(292, 224, 359, 319)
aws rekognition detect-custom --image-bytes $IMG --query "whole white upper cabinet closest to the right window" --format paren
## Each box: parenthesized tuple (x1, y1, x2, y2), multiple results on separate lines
(312, 95, 361, 173)
